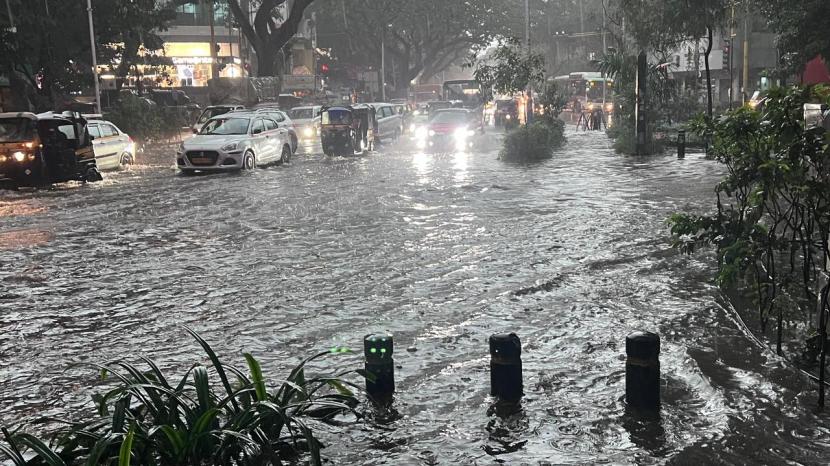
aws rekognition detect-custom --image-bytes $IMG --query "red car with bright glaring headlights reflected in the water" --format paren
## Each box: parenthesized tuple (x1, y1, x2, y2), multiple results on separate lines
(418, 108, 477, 151)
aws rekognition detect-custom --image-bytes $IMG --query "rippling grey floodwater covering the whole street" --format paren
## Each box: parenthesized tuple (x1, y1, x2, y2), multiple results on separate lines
(0, 132, 830, 465)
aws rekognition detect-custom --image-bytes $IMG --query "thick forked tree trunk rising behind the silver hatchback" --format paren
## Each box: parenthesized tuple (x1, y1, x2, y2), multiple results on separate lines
(227, 0, 314, 76)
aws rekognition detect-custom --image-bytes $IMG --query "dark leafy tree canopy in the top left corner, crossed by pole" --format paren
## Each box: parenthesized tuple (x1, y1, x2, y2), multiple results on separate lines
(0, 0, 174, 110)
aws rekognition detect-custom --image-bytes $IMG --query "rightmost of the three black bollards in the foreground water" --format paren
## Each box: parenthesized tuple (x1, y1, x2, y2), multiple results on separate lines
(625, 332, 660, 410)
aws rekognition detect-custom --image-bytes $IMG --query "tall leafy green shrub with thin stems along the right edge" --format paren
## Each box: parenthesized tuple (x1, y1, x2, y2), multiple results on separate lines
(669, 86, 830, 352)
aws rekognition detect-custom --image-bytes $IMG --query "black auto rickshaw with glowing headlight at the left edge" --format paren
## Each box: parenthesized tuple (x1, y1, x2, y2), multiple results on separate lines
(0, 112, 102, 186)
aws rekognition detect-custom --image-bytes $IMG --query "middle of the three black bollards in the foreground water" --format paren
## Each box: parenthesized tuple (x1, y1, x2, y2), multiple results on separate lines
(490, 333, 523, 401)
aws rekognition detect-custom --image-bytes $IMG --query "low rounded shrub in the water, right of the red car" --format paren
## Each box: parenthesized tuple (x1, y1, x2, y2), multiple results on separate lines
(499, 119, 565, 162)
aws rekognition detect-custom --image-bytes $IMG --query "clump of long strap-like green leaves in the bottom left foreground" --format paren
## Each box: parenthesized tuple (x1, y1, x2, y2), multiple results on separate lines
(0, 329, 357, 466)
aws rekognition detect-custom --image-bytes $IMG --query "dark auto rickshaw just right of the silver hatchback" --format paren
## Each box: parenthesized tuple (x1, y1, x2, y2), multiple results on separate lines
(320, 105, 377, 156)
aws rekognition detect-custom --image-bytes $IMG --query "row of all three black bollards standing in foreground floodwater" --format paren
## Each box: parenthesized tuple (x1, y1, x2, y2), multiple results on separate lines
(363, 332, 660, 411)
